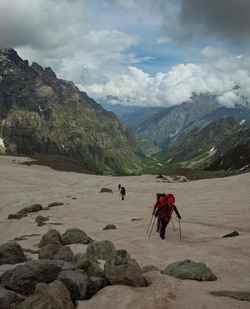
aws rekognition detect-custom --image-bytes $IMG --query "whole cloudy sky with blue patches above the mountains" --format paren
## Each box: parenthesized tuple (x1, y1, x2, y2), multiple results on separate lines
(0, 0, 250, 106)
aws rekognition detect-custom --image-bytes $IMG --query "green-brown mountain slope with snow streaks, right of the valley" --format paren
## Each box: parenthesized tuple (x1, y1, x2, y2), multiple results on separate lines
(155, 117, 250, 168)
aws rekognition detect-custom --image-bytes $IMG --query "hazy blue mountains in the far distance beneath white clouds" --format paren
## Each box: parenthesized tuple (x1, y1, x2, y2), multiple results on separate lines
(100, 93, 250, 149)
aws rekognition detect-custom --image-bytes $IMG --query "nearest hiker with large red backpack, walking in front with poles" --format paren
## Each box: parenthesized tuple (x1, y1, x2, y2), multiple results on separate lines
(155, 194, 181, 239)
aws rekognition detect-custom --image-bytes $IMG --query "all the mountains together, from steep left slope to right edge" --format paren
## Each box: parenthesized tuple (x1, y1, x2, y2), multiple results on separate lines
(0, 49, 250, 175)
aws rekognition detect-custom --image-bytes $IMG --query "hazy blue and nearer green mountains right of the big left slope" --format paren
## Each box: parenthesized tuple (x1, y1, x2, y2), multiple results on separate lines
(100, 93, 250, 170)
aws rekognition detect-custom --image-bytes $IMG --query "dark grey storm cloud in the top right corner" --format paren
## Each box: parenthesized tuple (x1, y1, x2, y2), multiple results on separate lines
(163, 0, 250, 48)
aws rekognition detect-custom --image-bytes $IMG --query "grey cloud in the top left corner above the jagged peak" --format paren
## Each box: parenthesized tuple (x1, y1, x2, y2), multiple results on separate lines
(0, 0, 84, 50)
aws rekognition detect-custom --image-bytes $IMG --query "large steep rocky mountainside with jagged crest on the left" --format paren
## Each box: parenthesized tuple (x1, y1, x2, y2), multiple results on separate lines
(0, 49, 159, 174)
